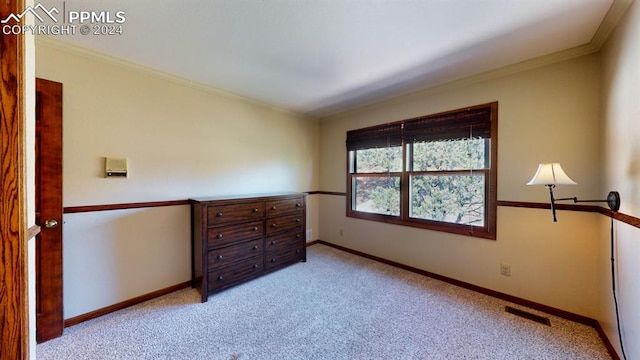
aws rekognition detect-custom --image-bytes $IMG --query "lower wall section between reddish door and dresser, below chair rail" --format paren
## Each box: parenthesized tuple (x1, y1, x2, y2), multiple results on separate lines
(63, 206, 191, 318)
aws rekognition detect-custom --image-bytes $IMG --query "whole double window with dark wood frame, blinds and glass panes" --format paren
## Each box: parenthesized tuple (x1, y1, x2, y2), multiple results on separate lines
(347, 102, 498, 239)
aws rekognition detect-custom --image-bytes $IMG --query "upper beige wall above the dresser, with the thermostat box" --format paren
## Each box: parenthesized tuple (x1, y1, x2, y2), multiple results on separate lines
(37, 42, 318, 206)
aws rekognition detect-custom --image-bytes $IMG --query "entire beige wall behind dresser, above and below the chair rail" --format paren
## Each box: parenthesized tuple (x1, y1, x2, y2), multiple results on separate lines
(36, 39, 319, 318)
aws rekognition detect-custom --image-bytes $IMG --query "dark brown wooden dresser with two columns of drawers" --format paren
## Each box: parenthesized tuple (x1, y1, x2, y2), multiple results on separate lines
(191, 193, 307, 302)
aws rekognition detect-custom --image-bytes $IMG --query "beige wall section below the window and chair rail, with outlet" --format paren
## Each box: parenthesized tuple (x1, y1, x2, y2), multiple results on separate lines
(320, 196, 598, 318)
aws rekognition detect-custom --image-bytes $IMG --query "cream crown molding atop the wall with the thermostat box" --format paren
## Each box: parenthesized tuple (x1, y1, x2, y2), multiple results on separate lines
(35, 35, 316, 120)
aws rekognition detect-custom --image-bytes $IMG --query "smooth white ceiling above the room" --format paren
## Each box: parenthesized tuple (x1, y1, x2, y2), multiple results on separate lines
(42, 0, 614, 117)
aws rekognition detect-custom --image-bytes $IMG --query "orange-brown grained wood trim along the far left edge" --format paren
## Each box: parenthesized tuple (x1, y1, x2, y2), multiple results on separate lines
(0, 0, 29, 359)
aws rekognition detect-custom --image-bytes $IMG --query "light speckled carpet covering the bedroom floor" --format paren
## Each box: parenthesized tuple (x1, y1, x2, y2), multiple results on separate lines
(37, 245, 610, 360)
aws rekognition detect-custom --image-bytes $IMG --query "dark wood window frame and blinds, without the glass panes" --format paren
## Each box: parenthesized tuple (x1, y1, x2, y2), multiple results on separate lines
(346, 102, 498, 240)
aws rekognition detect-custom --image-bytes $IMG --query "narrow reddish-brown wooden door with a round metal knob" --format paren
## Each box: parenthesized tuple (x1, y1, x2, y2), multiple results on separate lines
(35, 79, 64, 342)
